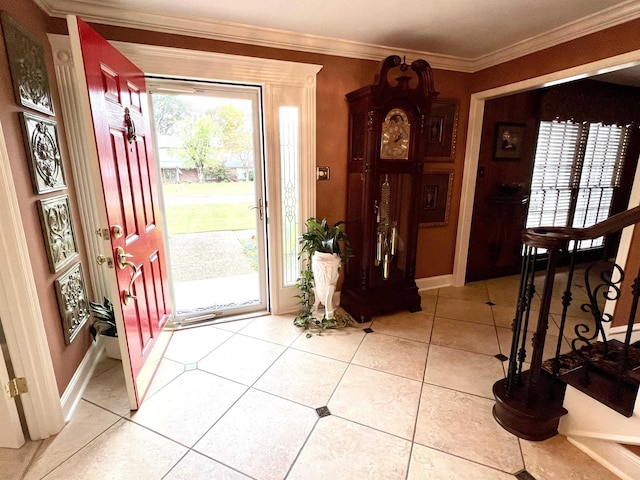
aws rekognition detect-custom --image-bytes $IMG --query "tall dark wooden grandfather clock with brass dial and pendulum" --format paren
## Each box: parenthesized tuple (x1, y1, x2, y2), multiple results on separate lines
(340, 55, 437, 322)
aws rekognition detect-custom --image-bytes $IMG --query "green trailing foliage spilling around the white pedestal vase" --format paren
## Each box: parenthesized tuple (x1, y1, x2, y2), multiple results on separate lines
(293, 217, 353, 338)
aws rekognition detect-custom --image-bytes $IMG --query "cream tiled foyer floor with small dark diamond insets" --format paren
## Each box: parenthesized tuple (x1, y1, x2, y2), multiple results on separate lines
(0, 278, 617, 480)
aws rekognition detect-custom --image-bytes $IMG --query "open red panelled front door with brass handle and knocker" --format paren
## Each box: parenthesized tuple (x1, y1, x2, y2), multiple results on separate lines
(70, 19, 171, 407)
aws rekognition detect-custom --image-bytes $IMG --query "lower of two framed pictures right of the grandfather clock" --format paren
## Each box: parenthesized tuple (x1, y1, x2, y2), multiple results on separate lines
(418, 170, 453, 227)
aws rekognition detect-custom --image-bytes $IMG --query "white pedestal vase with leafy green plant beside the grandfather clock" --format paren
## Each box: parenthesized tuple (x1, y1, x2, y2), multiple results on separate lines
(293, 217, 352, 336)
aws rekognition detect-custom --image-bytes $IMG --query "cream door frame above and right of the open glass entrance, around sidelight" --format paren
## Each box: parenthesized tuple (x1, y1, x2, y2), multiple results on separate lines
(111, 42, 322, 314)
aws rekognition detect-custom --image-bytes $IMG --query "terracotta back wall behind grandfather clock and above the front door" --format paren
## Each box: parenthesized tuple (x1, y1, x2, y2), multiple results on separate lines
(46, 19, 471, 278)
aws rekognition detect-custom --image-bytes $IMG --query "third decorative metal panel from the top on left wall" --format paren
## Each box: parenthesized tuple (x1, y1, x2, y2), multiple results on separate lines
(38, 195, 78, 273)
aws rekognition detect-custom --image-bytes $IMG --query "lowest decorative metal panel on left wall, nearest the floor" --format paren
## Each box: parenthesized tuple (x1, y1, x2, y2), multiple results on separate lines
(55, 263, 90, 345)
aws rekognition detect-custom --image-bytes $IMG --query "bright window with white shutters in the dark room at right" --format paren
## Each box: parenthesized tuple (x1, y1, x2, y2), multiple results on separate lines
(526, 121, 629, 250)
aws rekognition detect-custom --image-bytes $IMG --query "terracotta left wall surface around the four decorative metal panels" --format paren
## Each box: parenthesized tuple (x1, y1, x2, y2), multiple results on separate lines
(0, 0, 91, 394)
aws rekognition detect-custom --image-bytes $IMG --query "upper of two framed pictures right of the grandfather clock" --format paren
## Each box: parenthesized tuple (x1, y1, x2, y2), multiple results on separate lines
(425, 98, 459, 162)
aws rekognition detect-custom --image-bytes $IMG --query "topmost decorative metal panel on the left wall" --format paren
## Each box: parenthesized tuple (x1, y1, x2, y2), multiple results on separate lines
(1, 12, 54, 115)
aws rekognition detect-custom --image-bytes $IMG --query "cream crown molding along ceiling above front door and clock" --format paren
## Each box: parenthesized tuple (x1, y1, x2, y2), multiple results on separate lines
(34, 0, 640, 73)
